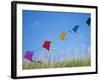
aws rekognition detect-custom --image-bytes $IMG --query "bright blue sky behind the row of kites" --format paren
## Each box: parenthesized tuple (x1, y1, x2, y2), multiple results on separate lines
(22, 10, 91, 61)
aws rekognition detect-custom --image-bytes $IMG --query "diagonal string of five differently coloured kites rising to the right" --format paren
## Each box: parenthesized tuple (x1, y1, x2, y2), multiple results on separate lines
(24, 18, 91, 61)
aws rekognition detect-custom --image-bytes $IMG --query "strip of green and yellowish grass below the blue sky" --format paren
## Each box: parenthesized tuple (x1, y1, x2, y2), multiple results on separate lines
(23, 58, 91, 69)
